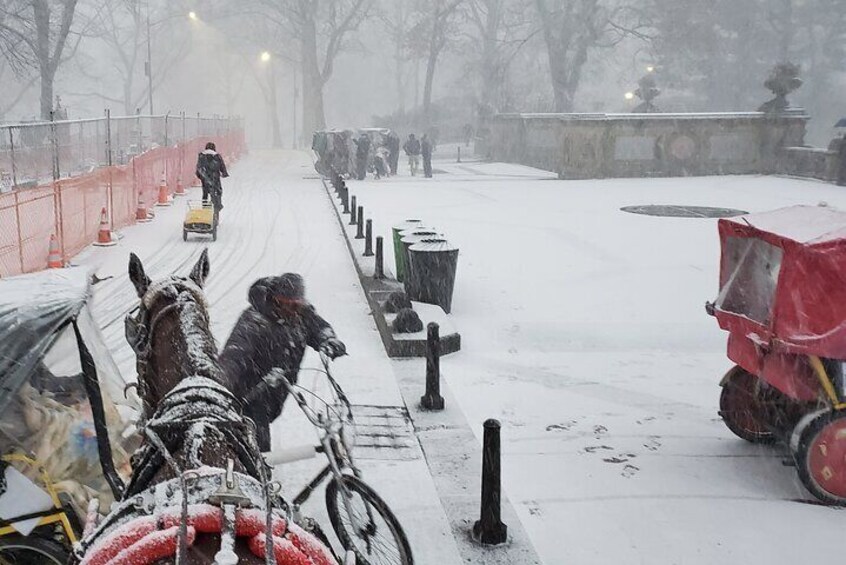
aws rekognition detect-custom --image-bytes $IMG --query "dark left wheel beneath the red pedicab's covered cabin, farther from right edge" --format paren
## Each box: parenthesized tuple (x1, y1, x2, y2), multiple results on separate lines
(720, 366, 775, 443)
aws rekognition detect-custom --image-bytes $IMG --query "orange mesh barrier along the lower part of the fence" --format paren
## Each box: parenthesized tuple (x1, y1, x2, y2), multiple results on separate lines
(0, 130, 246, 277)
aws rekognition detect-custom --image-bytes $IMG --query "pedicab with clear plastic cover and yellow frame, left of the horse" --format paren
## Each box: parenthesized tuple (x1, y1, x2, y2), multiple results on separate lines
(0, 268, 134, 564)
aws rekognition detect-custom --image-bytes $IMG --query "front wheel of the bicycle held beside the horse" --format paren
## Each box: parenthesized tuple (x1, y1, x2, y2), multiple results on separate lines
(326, 475, 414, 565)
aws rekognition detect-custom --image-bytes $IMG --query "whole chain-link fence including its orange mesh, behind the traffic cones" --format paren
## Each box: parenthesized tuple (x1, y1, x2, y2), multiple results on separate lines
(0, 114, 245, 276)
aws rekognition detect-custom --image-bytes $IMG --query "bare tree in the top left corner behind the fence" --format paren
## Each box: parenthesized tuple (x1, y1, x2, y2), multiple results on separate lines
(0, 0, 77, 120)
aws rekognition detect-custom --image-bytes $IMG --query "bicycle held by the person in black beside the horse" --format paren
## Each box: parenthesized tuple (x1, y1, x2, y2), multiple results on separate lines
(265, 353, 414, 565)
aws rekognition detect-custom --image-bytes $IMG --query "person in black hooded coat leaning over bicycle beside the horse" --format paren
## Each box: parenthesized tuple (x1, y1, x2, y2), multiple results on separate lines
(219, 273, 346, 451)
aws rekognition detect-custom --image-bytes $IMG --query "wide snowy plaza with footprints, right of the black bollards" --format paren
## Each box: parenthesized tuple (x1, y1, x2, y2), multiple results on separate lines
(342, 152, 846, 565)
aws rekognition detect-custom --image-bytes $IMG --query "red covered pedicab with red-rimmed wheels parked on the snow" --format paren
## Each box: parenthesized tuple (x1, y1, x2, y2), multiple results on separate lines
(707, 206, 846, 505)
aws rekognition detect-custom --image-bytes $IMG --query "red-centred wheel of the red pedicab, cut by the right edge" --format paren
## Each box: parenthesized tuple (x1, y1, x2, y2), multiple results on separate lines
(794, 410, 846, 506)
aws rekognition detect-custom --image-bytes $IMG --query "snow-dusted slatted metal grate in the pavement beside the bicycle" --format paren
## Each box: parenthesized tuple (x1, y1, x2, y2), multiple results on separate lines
(352, 404, 420, 461)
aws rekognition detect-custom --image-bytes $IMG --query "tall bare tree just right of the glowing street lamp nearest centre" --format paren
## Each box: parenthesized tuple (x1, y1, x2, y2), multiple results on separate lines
(259, 0, 371, 140)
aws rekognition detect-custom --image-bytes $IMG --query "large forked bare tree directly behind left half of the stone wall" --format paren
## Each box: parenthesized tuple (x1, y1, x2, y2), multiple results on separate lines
(535, 0, 647, 112)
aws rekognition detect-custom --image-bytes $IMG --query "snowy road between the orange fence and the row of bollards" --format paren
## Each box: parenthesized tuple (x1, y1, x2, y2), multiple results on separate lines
(74, 152, 458, 563)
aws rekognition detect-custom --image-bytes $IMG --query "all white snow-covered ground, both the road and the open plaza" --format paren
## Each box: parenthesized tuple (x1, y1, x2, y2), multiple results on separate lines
(76, 148, 846, 565)
